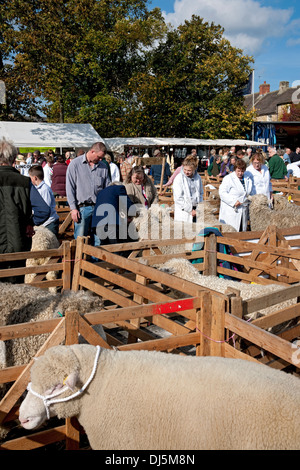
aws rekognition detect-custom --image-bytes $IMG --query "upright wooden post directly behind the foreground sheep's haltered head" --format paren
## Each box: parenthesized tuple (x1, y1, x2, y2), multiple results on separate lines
(65, 311, 80, 450)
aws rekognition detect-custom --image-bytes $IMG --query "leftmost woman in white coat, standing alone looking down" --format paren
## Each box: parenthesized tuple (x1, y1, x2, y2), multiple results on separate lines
(173, 155, 203, 222)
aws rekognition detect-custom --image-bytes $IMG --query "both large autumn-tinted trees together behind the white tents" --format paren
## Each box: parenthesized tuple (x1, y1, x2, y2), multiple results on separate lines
(0, 5, 252, 138)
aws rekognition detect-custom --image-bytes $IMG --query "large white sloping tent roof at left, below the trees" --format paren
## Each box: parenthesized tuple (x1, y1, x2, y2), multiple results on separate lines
(0, 121, 103, 148)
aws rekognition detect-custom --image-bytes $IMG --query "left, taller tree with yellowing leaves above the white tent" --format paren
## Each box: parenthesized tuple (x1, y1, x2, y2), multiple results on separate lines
(4, 0, 165, 129)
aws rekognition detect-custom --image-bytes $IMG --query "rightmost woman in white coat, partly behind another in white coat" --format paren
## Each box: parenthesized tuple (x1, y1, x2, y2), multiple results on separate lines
(245, 152, 272, 199)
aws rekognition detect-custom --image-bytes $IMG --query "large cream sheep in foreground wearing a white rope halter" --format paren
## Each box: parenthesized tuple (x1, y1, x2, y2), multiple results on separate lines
(19, 345, 300, 450)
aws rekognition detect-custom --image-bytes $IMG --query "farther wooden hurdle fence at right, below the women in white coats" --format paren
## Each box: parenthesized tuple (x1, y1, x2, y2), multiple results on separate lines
(105, 226, 300, 285)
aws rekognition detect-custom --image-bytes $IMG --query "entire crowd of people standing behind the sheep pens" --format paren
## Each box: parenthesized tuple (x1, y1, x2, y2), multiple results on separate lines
(0, 139, 300, 280)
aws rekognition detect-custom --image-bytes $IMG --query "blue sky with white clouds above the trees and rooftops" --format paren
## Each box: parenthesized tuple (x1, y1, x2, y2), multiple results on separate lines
(148, 0, 300, 92)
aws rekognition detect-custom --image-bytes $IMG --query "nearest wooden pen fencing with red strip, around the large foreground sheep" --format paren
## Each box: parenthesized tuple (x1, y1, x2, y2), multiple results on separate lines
(0, 238, 300, 450)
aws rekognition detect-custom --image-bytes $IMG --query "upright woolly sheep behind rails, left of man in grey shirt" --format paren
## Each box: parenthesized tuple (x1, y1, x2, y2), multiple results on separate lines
(24, 225, 59, 293)
